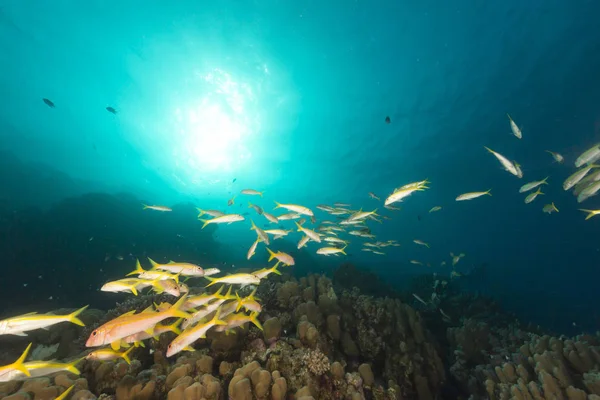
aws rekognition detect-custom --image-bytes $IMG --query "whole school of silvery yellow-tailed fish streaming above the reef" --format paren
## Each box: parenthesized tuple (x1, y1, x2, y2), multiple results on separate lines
(0, 115, 600, 399)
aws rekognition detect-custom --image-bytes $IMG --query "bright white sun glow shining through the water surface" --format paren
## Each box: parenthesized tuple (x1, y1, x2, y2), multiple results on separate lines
(175, 69, 257, 184)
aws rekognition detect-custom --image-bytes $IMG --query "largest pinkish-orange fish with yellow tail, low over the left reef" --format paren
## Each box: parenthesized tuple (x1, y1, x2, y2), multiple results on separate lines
(85, 295, 189, 348)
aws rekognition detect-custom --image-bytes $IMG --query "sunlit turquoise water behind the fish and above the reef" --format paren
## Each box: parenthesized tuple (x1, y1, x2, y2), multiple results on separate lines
(0, 1, 600, 331)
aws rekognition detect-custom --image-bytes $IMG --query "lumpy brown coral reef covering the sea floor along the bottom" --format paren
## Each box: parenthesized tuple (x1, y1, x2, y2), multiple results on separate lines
(0, 266, 600, 400)
